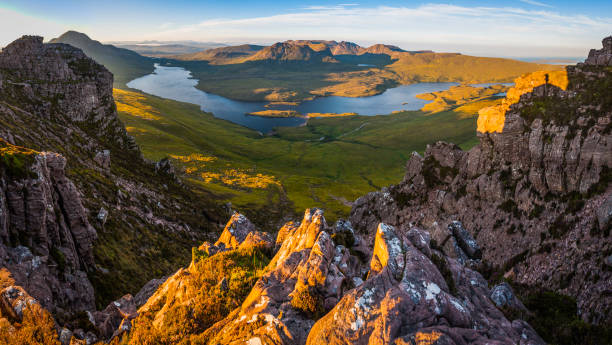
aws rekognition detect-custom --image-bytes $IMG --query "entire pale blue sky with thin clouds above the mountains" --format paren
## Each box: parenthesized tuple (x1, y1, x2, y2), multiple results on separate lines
(0, 0, 612, 57)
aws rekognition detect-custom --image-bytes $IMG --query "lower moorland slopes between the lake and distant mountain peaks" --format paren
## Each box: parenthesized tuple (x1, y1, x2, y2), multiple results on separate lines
(172, 53, 562, 101)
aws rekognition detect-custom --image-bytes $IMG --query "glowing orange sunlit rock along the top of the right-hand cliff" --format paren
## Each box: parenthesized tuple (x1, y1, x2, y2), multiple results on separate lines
(477, 70, 568, 133)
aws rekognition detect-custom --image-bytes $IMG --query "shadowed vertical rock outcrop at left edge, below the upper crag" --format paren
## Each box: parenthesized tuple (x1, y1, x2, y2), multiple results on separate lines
(0, 139, 96, 313)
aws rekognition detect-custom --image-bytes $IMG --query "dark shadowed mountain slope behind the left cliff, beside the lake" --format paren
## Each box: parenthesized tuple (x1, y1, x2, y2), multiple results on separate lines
(49, 31, 154, 88)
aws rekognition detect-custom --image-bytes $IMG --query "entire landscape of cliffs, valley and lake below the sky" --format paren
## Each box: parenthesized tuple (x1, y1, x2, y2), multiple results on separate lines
(0, 16, 612, 345)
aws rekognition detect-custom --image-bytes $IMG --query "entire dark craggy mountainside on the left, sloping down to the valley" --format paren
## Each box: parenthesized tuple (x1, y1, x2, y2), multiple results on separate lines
(0, 36, 226, 343)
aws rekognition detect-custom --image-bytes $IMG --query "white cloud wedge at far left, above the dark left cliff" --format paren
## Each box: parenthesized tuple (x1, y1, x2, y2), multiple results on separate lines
(0, 7, 68, 47)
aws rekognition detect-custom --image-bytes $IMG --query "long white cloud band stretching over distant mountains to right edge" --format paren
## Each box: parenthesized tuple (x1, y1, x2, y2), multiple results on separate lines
(149, 0, 612, 56)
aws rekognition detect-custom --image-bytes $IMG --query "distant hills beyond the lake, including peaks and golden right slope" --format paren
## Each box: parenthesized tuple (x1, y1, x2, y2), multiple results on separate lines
(171, 41, 562, 101)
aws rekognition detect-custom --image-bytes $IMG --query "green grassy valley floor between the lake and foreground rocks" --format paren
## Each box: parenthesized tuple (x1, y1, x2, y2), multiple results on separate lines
(116, 88, 476, 225)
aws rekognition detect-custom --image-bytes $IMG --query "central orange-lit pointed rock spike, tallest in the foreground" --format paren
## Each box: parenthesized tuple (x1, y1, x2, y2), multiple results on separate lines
(207, 209, 360, 345)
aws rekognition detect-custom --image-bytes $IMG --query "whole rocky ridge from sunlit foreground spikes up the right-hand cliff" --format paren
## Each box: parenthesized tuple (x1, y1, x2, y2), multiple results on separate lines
(113, 37, 612, 344)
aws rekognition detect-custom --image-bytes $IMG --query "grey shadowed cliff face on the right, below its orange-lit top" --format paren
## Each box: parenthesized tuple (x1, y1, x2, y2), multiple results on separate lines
(350, 38, 612, 323)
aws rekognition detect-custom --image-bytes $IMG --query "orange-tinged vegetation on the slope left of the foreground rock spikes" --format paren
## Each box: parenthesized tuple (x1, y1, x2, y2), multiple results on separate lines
(126, 249, 270, 344)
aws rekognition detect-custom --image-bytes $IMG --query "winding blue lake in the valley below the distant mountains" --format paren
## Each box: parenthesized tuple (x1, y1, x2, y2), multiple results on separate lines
(127, 64, 480, 133)
